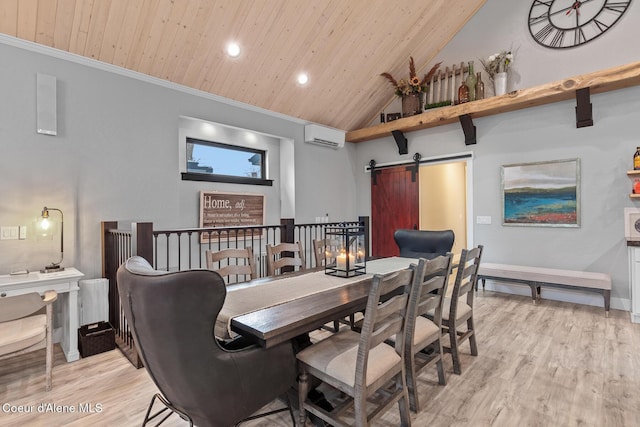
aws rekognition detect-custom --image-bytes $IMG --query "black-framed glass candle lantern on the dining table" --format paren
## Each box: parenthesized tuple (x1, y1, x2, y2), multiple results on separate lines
(324, 225, 367, 277)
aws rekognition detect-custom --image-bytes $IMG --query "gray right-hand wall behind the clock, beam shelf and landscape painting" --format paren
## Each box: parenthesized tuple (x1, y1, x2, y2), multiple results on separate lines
(356, 0, 640, 309)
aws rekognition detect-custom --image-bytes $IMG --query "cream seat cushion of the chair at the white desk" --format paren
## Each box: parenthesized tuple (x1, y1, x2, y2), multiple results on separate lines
(0, 314, 47, 356)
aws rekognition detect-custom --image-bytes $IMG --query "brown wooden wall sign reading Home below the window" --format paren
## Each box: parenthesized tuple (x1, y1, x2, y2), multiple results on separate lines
(200, 191, 264, 243)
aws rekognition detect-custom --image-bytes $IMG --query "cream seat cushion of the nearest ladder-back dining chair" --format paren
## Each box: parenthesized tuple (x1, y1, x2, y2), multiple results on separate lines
(297, 330, 402, 387)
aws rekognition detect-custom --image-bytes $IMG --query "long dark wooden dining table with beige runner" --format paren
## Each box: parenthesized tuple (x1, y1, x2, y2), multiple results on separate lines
(215, 257, 418, 348)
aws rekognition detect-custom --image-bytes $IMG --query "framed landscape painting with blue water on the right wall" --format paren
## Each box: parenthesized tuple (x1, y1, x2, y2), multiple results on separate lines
(502, 159, 580, 227)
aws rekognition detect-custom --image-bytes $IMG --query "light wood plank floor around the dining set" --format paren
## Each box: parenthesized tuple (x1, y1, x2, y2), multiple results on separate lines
(0, 291, 640, 427)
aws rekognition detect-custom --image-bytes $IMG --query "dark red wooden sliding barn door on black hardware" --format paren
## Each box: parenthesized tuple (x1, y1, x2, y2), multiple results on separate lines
(371, 166, 420, 257)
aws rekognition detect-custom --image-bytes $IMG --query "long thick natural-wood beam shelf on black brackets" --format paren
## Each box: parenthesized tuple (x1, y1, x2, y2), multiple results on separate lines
(345, 62, 640, 142)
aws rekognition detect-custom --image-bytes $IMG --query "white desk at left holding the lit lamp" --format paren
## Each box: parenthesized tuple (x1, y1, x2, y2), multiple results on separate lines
(0, 267, 84, 362)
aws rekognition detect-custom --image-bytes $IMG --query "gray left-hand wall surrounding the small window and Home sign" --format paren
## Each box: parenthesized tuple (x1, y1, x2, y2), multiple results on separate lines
(0, 36, 356, 278)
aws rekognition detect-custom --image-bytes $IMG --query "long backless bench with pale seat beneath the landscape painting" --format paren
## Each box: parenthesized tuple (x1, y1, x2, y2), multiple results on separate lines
(476, 263, 611, 317)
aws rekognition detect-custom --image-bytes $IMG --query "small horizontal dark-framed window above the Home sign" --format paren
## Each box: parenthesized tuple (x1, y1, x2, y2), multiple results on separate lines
(182, 137, 272, 185)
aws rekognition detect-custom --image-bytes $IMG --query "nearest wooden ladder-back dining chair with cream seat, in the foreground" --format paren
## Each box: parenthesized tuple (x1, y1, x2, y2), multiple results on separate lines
(297, 269, 413, 426)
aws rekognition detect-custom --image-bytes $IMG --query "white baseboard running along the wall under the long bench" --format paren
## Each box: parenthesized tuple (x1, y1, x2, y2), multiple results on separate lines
(478, 279, 628, 312)
